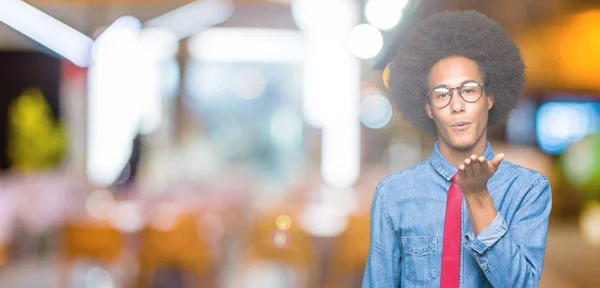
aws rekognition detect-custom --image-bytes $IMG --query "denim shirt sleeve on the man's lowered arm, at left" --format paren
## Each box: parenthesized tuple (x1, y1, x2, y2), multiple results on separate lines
(362, 183, 402, 288)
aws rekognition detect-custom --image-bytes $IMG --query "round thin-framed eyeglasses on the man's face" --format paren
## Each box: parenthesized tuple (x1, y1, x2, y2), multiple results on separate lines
(427, 81, 485, 108)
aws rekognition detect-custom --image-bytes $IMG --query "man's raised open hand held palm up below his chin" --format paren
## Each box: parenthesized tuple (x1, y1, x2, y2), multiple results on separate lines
(457, 153, 504, 196)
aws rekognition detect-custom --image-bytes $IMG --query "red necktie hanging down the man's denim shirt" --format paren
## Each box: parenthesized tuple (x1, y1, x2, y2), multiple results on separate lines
(440, 172, 462, 288)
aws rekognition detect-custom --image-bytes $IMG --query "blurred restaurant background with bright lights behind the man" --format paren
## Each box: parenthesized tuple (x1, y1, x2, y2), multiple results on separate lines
(0, 0, 600, 287)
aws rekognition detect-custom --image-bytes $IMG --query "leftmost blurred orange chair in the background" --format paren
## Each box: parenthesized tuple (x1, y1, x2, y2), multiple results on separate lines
(60, 222, 124, 287)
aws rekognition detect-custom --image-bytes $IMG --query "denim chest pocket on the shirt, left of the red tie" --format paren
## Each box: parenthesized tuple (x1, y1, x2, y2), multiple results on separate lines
(401, 236, 441, 286)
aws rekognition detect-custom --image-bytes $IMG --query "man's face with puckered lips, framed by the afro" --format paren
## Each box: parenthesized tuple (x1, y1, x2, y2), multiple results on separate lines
(425, 57, 494, 150)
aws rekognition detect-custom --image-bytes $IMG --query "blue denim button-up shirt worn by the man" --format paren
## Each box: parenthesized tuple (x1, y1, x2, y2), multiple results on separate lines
(362, 142, 552, 288)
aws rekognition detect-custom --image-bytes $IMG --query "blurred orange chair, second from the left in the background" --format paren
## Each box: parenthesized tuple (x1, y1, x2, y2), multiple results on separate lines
(138, 214, 213, 287)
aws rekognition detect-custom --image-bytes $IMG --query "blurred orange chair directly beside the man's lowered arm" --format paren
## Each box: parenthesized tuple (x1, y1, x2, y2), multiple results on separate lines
(327, 214, 370, 287)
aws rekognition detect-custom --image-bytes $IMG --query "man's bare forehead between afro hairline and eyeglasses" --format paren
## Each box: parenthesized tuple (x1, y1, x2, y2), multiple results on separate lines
(429, 56, 483, 88)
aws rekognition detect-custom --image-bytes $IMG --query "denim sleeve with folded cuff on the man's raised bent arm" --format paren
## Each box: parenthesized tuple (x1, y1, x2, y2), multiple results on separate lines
(464, 176, 552, 287)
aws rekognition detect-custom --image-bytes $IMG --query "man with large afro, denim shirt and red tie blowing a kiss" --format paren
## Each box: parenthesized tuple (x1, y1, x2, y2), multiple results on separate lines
(363, 11, 551, 288)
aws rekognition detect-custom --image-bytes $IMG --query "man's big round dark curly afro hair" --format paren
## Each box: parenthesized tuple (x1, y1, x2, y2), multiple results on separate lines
(388, 11, 525, 135)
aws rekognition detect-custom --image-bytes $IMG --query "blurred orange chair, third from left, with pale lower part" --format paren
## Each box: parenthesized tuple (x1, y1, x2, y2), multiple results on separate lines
(241, 214, 319, 287)
